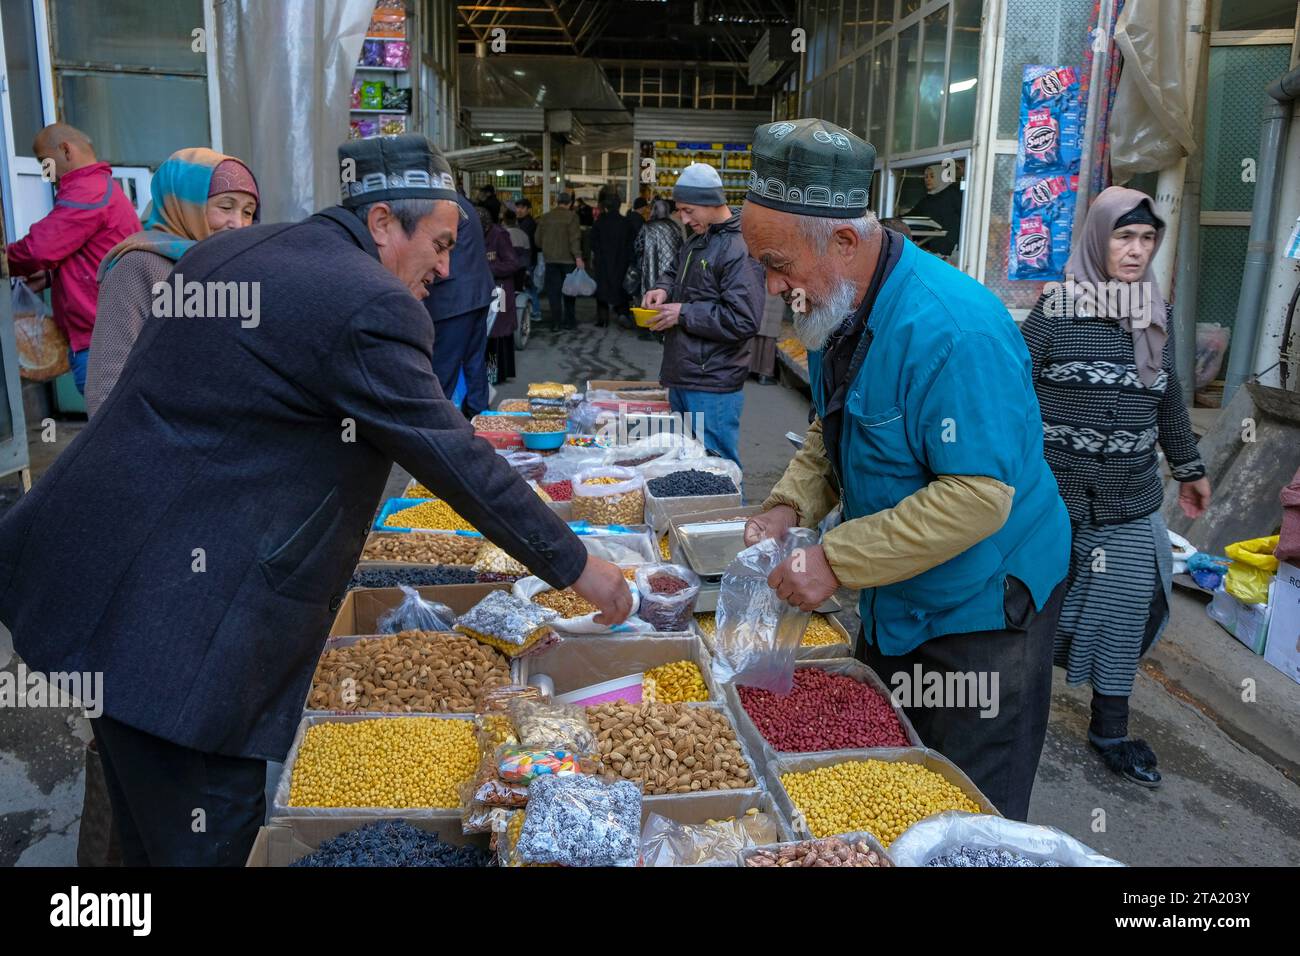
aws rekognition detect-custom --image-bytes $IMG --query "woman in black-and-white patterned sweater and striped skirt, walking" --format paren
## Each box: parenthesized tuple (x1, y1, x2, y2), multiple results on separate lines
(1022, 186, 1210, 787)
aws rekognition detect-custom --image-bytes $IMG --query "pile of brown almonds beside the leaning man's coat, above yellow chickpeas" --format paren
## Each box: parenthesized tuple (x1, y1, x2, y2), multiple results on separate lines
(307, 631, 510, 714)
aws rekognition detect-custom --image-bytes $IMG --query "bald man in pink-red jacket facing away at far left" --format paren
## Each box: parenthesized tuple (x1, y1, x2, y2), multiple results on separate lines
(5, 122, 140, 394)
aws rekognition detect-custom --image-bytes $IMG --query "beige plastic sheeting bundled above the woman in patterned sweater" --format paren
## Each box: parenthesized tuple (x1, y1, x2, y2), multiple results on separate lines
(1110, 0, 1196, 183)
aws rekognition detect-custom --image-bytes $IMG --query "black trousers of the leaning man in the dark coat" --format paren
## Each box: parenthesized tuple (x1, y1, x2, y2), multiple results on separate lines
(91, 717, 267, 866)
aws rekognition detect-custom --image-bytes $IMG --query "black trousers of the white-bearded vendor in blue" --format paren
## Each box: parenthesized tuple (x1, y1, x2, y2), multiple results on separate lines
(858, 578, 1065, 821)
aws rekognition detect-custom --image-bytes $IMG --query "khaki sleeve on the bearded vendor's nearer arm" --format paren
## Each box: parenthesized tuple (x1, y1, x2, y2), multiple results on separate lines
(821, 471, 1015, 588)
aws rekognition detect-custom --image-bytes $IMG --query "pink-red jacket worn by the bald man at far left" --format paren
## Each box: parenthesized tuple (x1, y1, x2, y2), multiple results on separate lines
(5, 163, 140, 351)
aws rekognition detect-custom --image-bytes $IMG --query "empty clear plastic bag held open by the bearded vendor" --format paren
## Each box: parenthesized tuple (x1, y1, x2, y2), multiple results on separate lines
(714, 528, 816, 696)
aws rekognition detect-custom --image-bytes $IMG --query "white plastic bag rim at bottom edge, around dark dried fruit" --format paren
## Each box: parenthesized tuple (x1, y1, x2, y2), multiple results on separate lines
(889, 810, 1125, 866)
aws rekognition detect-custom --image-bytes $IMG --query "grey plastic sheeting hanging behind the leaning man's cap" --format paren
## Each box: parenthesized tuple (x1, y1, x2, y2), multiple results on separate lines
(216, 0, 374, 222)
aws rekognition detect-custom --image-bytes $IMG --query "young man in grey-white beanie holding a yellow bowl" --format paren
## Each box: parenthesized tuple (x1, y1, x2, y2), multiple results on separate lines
(644, 163, 764, 464)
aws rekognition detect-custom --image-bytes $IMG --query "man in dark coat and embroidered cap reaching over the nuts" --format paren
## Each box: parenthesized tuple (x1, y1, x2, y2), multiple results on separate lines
(0, 135, 631, 865)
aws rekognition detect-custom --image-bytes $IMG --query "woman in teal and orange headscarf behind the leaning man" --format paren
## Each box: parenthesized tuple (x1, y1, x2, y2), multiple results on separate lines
(86, 147, 261, 416)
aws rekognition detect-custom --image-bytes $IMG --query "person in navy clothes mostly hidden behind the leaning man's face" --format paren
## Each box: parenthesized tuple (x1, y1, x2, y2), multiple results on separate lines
(424, 196, 495, 418)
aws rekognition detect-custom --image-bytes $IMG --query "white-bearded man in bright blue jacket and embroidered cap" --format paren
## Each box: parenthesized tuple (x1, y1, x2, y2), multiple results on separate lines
(742, 120, 1070, 819)
